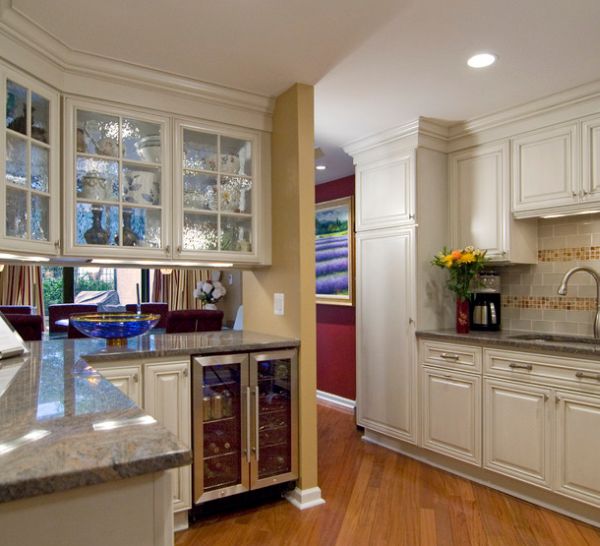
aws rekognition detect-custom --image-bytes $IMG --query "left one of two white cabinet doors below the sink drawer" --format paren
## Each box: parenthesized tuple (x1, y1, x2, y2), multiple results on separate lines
(483, 378, 553, 489)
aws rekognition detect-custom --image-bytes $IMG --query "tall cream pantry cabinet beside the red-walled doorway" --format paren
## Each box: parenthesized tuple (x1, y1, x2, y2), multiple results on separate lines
(346, 120, 452, 444)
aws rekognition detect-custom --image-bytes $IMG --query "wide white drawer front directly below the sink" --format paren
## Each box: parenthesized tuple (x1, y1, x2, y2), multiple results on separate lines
(483, 349, 600, 393)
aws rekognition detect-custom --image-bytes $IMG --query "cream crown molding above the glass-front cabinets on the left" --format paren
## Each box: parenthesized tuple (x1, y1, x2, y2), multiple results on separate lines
(0, 0, 275, 117)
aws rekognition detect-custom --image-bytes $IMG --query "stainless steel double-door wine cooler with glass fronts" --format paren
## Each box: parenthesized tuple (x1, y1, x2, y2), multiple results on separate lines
(193, 350, 298, 504)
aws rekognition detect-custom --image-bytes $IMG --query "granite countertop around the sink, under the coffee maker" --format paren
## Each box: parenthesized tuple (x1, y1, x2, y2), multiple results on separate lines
(417, 329, 600, 359)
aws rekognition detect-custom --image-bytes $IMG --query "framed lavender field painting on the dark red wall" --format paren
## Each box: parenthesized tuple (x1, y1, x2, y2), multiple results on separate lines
(315, 197, 354, 305)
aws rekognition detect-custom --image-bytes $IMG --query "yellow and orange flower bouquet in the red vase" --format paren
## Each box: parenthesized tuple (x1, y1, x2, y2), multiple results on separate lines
(431, 246, 489, 300)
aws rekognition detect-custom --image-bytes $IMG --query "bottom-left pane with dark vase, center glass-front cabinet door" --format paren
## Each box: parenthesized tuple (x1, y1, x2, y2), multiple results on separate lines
(76, 203, 119, 245)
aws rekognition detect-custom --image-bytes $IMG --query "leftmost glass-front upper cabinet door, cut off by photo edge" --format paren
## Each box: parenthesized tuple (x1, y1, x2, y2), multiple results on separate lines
(0, 65, 60, 255)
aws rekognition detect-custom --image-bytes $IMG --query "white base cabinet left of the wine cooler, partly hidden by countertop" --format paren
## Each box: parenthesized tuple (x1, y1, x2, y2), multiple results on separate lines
(96, 359, 192, 512)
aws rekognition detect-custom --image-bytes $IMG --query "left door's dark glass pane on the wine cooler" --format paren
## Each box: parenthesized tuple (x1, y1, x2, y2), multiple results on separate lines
(202, 364, 242, 491)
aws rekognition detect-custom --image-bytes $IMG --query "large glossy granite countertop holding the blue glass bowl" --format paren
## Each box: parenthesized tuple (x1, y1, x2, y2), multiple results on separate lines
(0, 331, 298, 502)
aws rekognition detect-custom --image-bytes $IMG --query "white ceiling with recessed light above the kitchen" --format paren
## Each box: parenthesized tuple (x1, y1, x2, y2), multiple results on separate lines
(12, 0, 600, 181)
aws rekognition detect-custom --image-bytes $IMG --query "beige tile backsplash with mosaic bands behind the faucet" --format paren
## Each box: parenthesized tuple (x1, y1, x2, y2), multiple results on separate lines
(498, 214, 600, 335)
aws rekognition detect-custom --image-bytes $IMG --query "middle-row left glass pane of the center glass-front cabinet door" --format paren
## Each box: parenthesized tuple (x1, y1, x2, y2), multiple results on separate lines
(77, 156, 119, 201)
